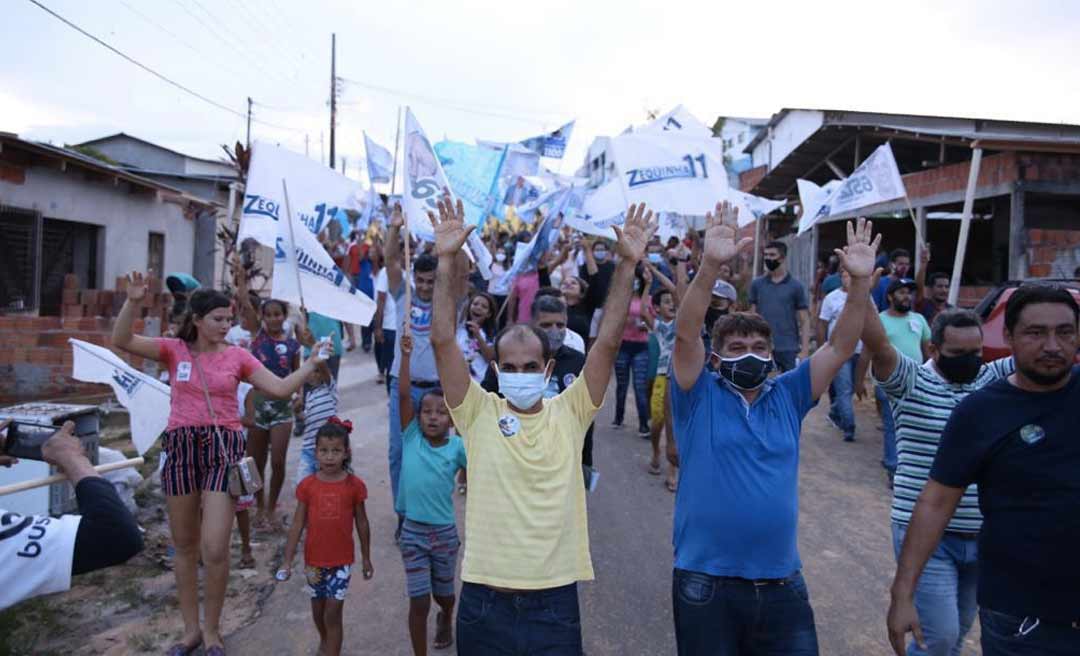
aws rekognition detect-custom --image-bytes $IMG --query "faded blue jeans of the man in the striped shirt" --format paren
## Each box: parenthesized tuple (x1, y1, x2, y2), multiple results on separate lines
(892, 522, 978, 656)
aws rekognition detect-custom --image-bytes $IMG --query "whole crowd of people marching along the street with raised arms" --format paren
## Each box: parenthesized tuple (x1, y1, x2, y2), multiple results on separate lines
(2, 190, 1080, 656)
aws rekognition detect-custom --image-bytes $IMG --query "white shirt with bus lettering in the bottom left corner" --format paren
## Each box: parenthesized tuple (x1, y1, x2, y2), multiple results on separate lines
(0, 510, 82, 611)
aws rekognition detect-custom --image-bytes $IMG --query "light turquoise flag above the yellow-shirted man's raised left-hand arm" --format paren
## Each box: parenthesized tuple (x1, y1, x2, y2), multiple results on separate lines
(435, 142, 507, 226)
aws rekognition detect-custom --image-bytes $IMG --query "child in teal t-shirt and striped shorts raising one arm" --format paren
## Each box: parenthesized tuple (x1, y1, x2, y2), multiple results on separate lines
(394, 334, 465, 656)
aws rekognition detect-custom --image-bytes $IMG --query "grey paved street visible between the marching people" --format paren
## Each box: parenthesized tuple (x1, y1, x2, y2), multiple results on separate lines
(228, 351, 980, 656)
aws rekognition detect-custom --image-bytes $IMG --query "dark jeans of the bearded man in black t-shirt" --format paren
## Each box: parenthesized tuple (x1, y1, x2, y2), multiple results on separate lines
(978, 608, 1080, 656)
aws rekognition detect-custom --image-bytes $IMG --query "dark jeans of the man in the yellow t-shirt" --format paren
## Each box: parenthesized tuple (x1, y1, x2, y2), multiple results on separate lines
(457, 583, 582, 656)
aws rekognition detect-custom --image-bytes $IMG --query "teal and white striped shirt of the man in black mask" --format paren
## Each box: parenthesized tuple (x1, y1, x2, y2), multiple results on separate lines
(879, 351, 1015, 533)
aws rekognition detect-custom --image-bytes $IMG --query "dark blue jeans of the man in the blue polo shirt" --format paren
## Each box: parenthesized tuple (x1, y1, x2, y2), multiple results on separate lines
(672, 570, 818, 656)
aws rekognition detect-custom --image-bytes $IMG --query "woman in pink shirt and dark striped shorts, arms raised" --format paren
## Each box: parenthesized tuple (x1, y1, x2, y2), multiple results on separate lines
(112, 273, 327, 656)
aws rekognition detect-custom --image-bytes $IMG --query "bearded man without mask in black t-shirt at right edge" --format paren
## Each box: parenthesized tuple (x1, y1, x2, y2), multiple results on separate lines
(888, 284, 1080, 656)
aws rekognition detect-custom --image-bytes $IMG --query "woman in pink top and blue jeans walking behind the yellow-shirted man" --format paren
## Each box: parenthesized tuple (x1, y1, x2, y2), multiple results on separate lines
(612, 264, 652, 438)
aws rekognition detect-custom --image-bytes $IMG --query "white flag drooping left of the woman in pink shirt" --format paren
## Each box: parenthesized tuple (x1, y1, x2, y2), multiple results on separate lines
(68, 339, 170, 455)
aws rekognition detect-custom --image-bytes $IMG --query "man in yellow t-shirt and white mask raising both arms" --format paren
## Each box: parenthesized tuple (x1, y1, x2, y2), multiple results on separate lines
(429, 193, 657, 656)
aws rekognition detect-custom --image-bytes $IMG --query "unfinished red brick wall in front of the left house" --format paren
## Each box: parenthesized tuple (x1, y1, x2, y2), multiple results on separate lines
(0, 276, 172, 404)
